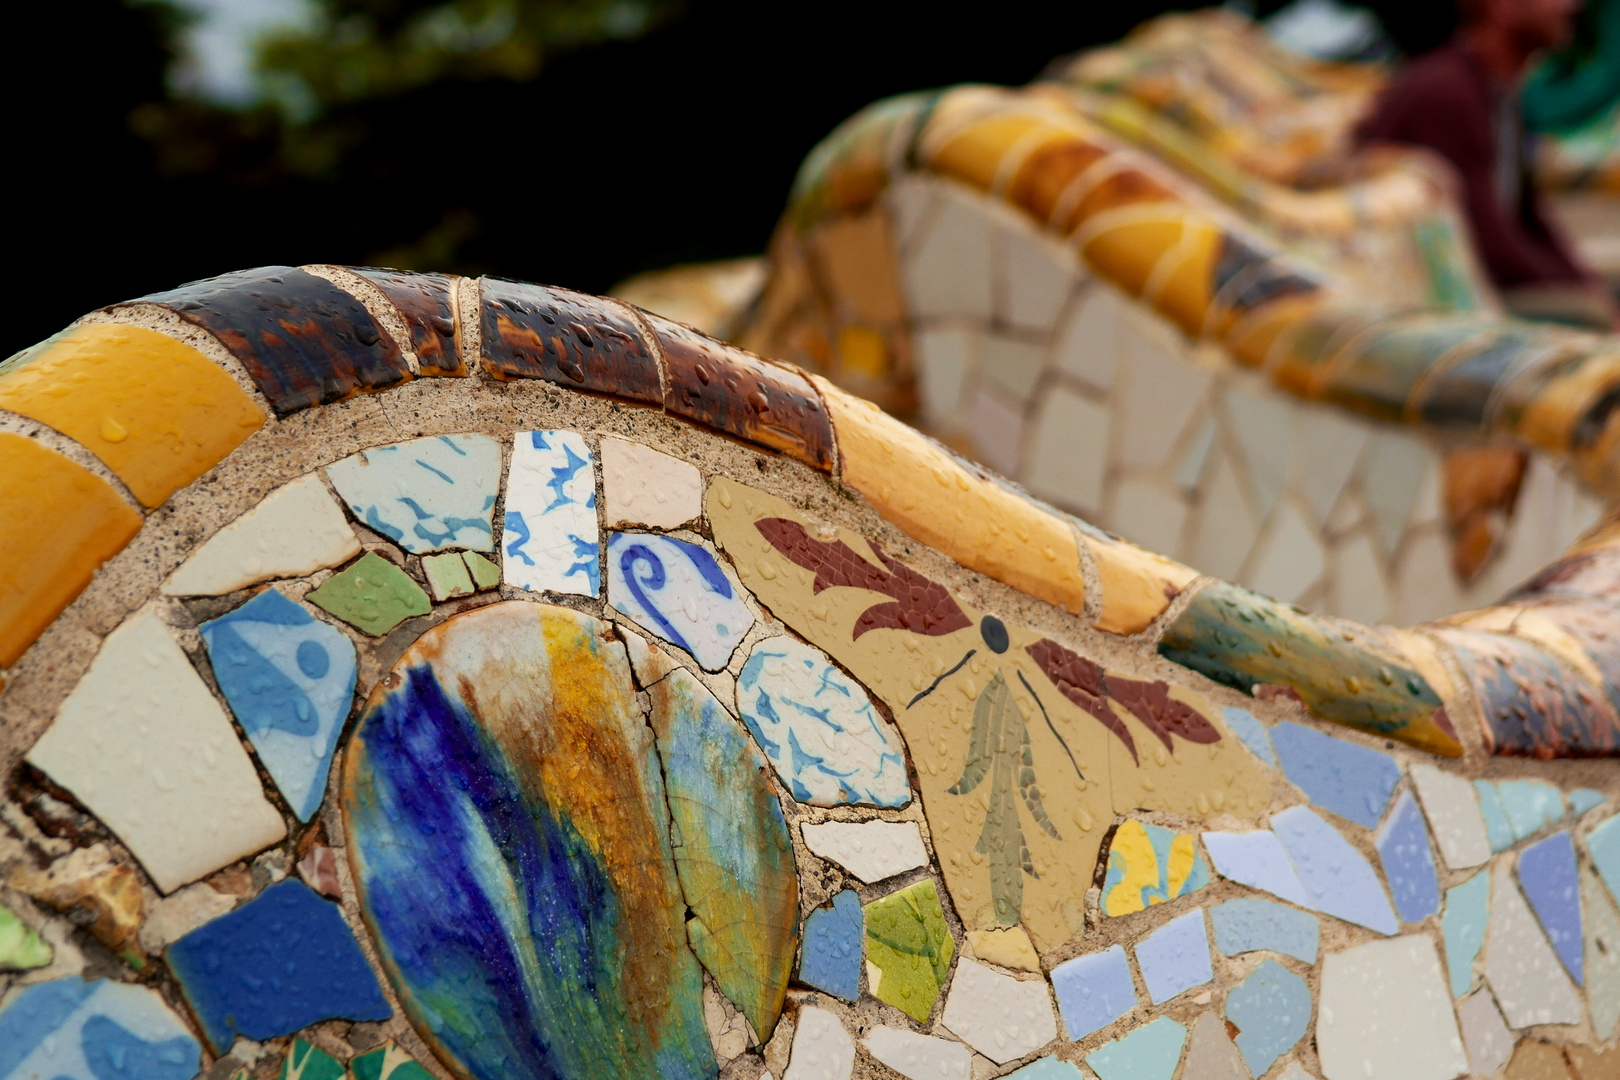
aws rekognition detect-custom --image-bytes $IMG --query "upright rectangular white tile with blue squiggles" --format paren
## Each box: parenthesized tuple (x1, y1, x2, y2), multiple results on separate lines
(501, 431, 601, 596)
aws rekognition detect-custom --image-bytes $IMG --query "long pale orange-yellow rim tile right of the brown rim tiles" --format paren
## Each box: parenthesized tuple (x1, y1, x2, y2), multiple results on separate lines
(812, 376, 1085, 614)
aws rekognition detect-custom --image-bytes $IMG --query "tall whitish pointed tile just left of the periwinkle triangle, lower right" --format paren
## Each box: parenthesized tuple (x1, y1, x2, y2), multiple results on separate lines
(1484, 861, 1581, 1028)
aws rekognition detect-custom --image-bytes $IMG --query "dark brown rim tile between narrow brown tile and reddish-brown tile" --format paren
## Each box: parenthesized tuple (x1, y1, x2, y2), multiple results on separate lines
(480, 277, 664, 405)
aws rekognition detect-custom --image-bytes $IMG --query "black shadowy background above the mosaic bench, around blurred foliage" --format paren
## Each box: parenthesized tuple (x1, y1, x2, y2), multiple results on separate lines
(0, 0, 1453, 348)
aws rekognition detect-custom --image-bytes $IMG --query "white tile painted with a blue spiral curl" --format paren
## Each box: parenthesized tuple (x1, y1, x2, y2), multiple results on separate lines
(608, 533, 753, 672)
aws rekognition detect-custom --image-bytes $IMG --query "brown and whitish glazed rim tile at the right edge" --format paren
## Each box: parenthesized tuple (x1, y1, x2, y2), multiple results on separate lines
(1434, 627, 1620, 759)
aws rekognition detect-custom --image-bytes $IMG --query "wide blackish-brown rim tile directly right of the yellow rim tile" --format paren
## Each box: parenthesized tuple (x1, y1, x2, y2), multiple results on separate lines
(139, 266, 410, 416)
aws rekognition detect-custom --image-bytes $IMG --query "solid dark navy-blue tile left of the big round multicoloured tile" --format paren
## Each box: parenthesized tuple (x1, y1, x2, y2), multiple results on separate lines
(168, 878, 394, 1054)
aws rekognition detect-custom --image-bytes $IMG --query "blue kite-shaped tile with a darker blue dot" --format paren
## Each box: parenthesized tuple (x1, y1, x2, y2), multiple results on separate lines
(203, 589, 356, 821)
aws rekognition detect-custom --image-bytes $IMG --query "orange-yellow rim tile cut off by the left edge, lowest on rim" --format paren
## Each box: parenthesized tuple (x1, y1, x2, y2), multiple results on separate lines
(0, 432, 141, 667)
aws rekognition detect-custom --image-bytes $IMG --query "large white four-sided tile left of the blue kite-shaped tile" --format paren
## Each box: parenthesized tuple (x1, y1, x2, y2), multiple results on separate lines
(28, 612, 287, 892)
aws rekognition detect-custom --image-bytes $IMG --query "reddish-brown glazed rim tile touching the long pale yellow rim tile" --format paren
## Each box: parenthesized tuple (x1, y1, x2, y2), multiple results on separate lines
(643, 313, 833, 473)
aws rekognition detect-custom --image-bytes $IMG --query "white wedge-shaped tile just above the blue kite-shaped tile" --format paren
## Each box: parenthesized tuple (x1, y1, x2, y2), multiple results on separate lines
(164, 473, 360, 596)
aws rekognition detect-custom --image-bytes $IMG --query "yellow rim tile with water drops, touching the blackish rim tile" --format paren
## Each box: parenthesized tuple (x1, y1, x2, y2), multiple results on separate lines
(0, 322, 264, 507)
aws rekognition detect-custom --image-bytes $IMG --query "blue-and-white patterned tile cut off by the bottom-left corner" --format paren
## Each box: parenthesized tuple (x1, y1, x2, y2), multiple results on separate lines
(0, 975, 203, 1080)
